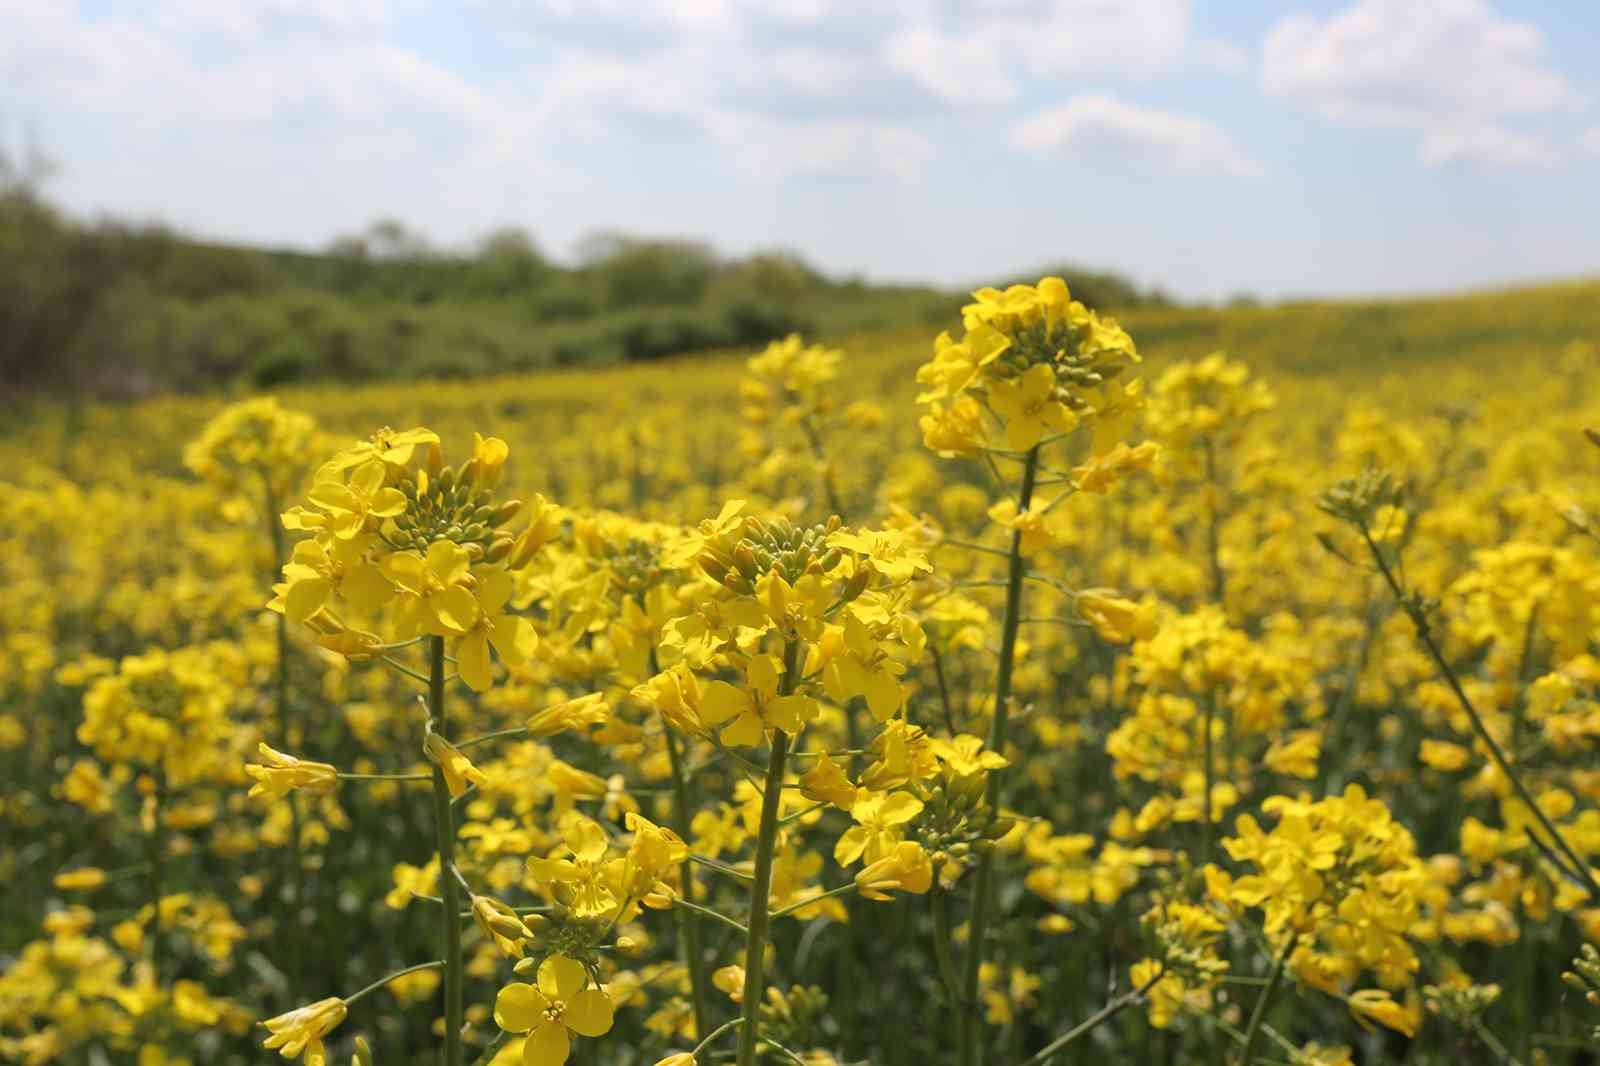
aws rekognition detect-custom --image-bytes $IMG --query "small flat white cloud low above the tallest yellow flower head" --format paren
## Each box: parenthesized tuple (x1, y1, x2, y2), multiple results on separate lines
(1011, 93, 1262, 178)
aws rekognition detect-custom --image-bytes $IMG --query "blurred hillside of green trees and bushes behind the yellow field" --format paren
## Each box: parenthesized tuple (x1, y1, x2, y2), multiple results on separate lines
(0, 184, 1162, 399)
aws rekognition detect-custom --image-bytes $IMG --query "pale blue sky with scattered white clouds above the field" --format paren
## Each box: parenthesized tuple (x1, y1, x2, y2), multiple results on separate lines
(0, 0, 1600, 298)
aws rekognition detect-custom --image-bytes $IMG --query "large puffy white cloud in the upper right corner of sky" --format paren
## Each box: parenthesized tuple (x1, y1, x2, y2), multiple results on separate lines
(1262, 0, 1579, 165)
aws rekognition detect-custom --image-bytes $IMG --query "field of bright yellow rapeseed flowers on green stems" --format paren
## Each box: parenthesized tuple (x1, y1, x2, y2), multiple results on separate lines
(0, 279, 1600, 1066)
